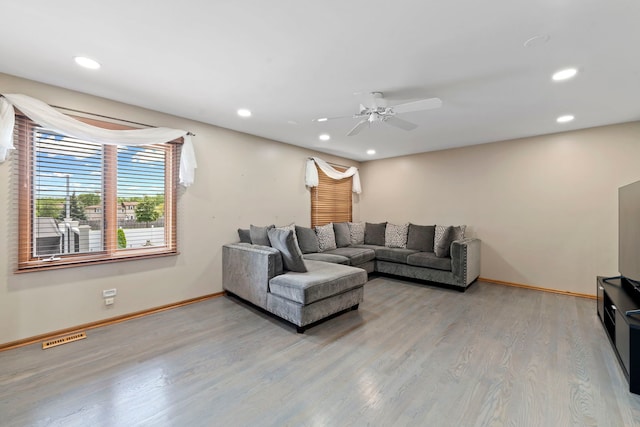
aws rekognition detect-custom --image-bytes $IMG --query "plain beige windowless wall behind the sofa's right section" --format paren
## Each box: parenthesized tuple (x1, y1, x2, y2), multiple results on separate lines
(360, 122, 640, 294)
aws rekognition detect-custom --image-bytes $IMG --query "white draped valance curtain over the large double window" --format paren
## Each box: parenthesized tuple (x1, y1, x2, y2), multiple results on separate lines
(0, 94, 197, 187)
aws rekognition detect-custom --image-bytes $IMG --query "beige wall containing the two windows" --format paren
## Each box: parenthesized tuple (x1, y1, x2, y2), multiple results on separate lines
(0, 74, 358, 343)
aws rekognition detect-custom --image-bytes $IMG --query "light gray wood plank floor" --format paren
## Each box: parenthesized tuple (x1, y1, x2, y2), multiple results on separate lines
(0, 277, 640, 427)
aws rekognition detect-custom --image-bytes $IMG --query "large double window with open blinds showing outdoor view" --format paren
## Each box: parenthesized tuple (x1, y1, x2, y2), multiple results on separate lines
(15, 114, 181, 271)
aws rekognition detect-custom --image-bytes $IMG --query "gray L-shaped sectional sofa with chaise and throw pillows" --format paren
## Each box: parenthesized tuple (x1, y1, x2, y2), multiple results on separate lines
(222, 223, 480, 332)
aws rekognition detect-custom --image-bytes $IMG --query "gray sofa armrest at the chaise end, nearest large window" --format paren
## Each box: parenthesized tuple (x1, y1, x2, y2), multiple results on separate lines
(222, 243, 283, 308)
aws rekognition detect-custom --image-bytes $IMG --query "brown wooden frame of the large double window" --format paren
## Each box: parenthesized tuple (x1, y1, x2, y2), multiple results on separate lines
(14, 111, 183, 273)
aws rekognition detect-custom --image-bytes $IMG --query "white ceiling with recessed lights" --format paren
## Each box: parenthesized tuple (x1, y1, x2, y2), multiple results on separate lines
(0, 0, 640, 161)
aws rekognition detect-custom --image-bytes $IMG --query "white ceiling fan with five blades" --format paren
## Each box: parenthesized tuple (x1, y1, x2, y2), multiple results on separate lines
(314, 92, 442, 136)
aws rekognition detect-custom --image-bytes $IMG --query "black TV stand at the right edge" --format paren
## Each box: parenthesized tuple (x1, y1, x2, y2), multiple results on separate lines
(596, 276, 640, 394)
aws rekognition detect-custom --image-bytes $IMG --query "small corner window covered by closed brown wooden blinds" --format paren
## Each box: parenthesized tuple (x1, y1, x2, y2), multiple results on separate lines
(311, 166, 353, 227)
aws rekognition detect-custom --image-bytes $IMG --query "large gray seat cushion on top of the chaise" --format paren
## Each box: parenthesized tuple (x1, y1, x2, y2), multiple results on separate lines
(269, 261, 367, 305)
